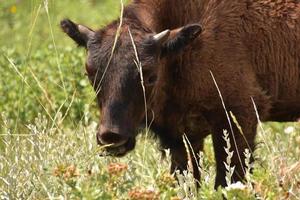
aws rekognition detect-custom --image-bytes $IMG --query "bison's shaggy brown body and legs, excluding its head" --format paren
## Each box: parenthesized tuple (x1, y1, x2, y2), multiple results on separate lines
(61, 0, 300, 187)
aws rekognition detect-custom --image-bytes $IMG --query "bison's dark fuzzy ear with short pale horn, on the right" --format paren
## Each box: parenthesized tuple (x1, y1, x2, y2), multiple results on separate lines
(153, 24, 202, 56)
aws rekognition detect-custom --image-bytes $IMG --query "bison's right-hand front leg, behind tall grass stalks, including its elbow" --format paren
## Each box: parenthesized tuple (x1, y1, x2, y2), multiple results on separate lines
(208, 87, 270, 188)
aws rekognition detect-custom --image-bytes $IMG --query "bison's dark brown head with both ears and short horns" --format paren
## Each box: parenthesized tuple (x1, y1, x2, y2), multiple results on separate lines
(61, 19, 201, 156)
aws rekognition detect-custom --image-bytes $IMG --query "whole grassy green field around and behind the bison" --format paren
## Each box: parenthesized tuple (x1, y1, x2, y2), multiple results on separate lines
(0, 0, 300, 200)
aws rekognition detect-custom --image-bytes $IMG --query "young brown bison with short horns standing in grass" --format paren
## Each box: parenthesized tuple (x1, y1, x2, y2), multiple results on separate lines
(61, 0, 300, 187)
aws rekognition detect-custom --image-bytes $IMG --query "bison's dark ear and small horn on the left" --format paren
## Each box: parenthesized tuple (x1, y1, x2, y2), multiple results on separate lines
(60, 19, 95, 48)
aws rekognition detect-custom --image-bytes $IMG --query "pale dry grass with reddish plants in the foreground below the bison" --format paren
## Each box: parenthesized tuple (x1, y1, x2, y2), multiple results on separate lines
(0, 112, 300, 199)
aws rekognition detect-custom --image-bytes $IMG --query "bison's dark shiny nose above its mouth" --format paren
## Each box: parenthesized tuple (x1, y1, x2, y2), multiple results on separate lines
(97, 126, 129, 147)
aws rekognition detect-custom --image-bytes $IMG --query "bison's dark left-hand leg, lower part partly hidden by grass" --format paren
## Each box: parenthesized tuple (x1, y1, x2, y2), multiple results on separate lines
(170, 139, 203, 183)
